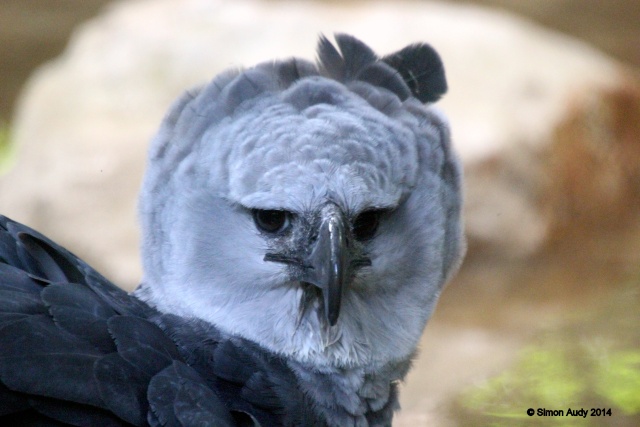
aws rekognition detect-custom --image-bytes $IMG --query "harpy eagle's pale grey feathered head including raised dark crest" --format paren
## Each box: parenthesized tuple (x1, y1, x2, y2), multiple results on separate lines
(136, 35, 464, 367)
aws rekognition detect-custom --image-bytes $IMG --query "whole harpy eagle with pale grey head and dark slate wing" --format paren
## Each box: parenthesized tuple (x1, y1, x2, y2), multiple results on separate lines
(0, 34, 464, 426)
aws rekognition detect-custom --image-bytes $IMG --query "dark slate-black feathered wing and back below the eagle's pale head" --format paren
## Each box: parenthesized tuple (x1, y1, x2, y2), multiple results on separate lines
(0, 216, 322, 426)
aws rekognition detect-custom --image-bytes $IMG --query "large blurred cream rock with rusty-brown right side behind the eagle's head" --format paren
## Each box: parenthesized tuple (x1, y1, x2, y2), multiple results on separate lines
(0, 0, 640, 288)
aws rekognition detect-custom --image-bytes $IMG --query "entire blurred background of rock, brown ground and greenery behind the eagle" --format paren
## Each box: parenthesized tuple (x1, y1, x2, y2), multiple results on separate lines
(0, 0, 640, 426)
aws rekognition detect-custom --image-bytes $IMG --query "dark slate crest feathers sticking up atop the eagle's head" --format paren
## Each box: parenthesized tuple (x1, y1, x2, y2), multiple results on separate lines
(318, 34, 447, 102)
